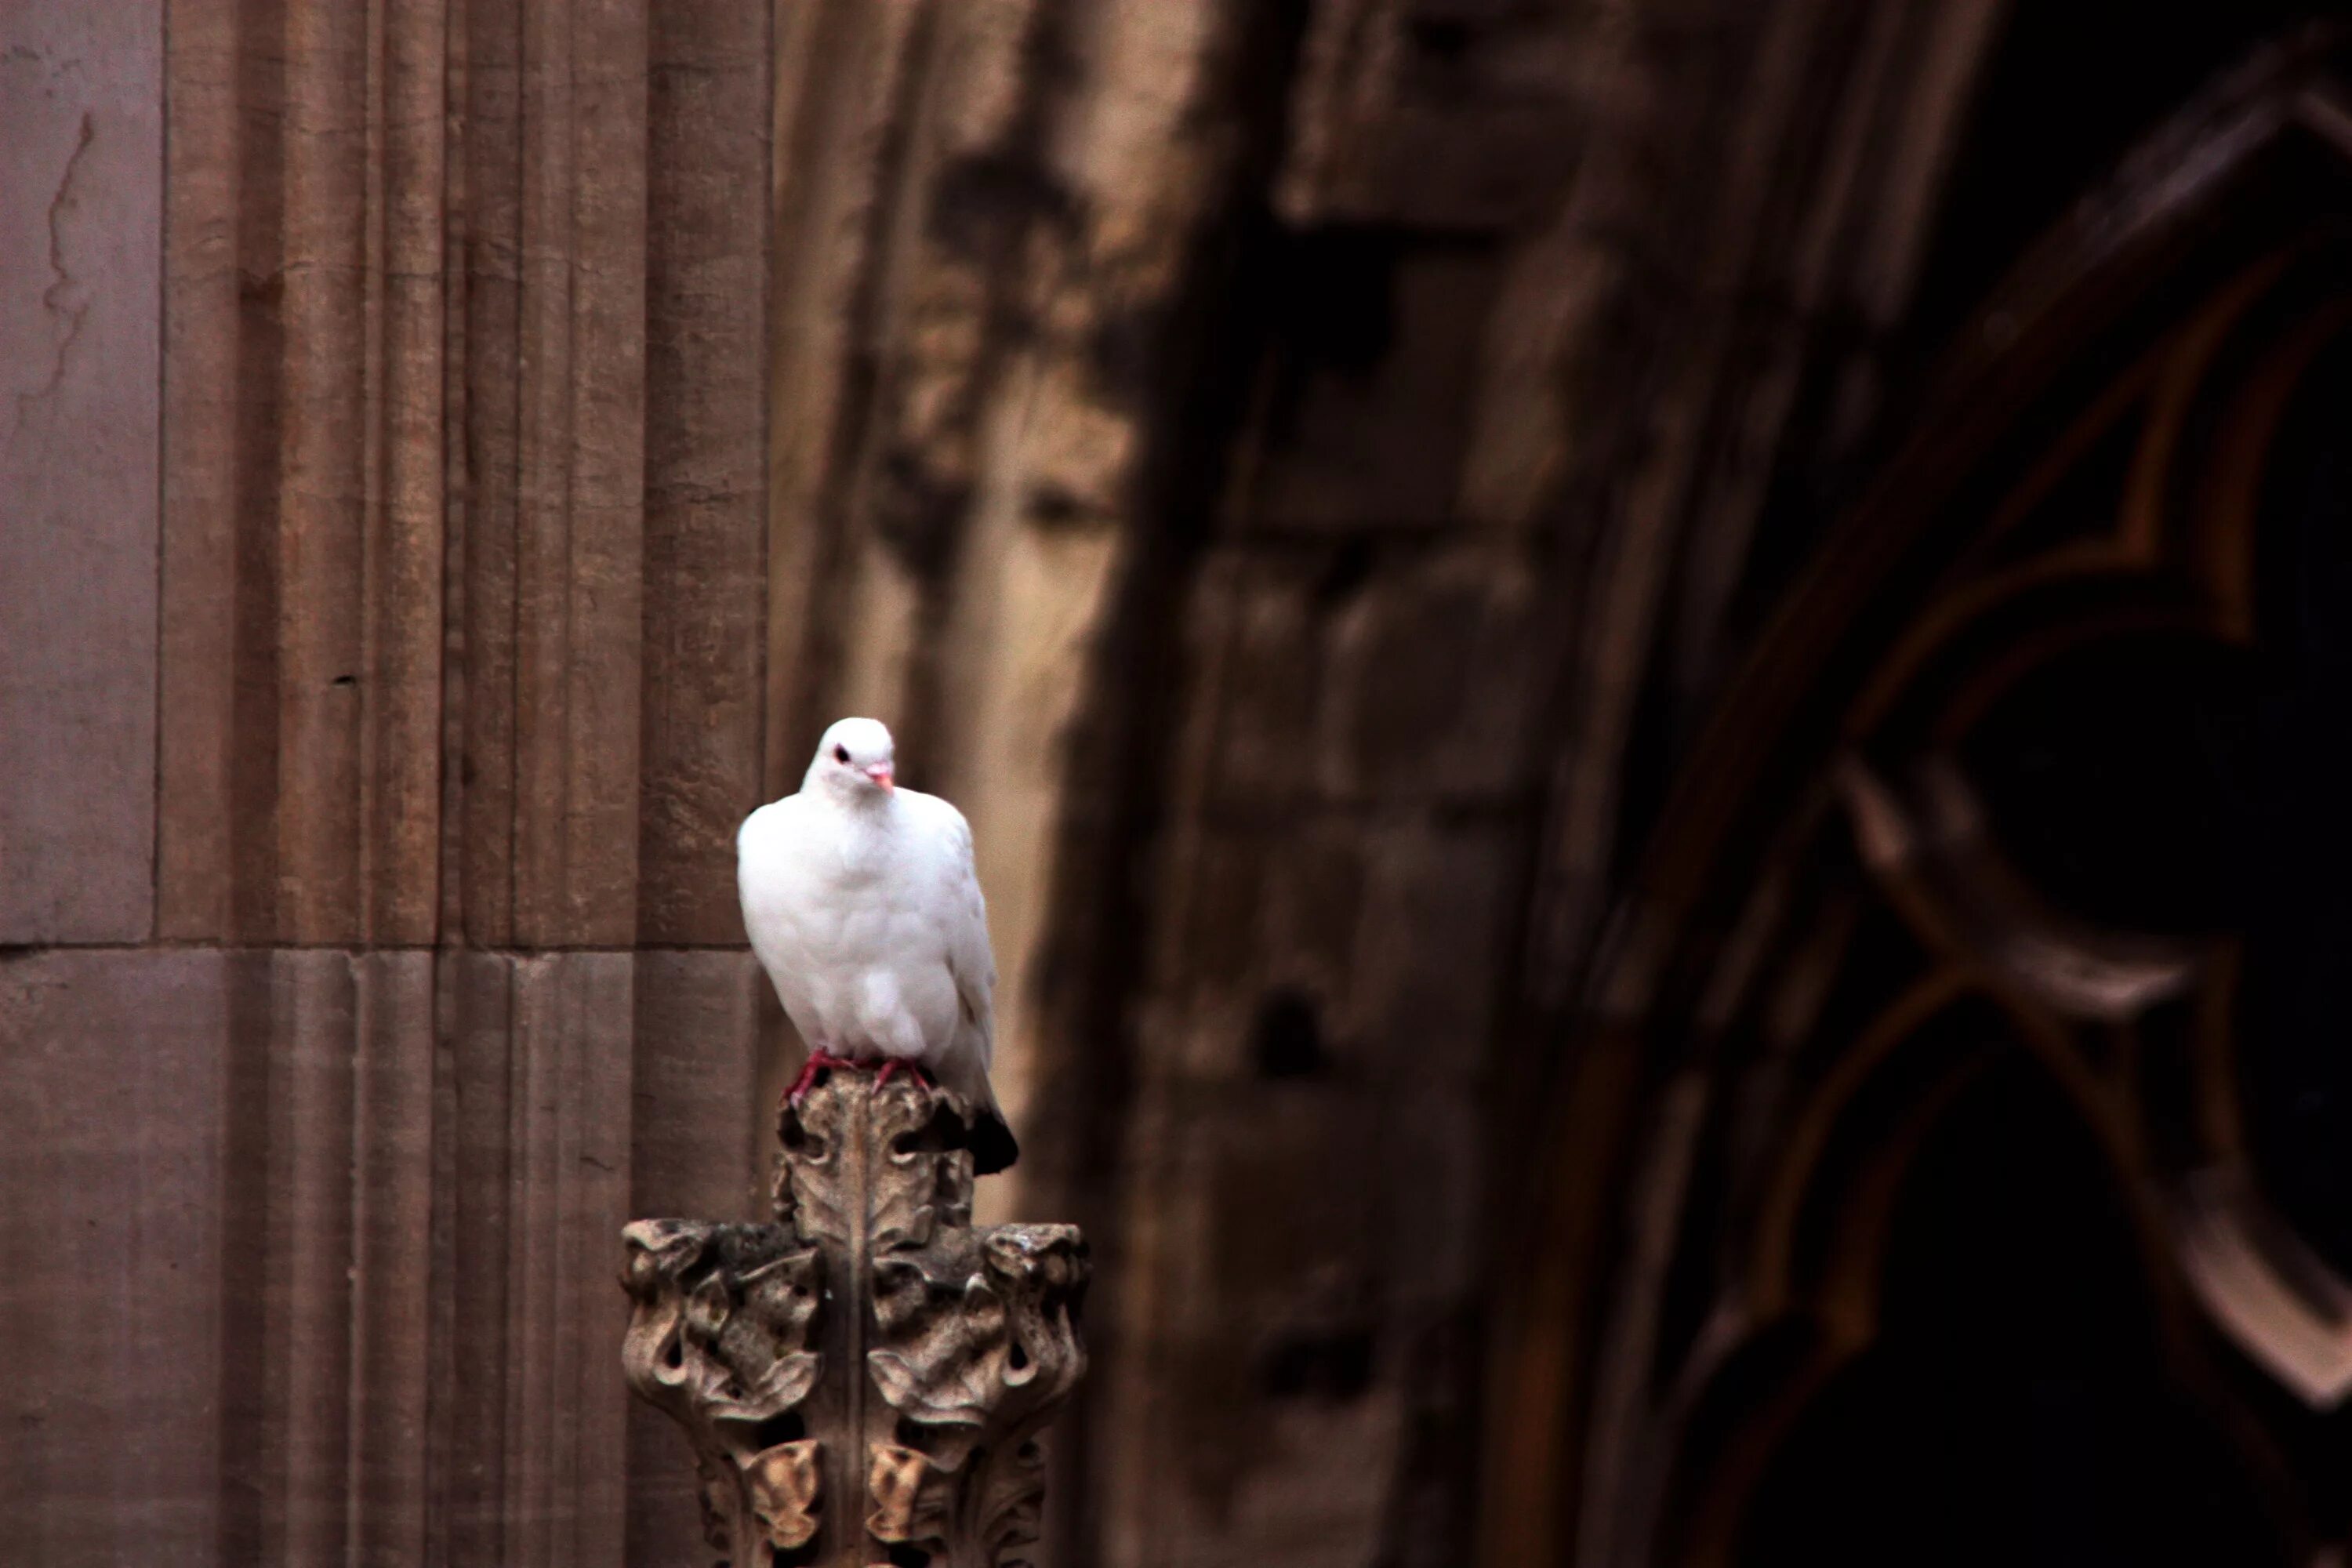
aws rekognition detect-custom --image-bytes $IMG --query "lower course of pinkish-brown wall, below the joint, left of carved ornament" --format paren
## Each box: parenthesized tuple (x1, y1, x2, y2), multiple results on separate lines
(0, 949, 764, 1563)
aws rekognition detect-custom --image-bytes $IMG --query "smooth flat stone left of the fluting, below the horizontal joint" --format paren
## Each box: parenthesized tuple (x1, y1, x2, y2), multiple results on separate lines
(0, 947, 224, 1563)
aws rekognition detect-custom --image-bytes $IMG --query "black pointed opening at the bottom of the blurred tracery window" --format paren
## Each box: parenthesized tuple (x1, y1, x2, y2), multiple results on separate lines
(1738, 1051, 2286, 1568)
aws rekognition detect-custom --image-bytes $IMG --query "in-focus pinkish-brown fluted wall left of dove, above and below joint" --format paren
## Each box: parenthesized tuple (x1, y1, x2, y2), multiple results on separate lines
(0, 0, 771, 1563)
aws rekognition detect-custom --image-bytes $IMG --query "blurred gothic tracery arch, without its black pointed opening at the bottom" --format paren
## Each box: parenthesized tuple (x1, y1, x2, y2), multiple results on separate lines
(1489, 33, 2352, 1568)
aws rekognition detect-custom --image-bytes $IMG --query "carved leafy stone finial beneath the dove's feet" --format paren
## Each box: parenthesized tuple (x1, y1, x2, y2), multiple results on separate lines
(621, 1069, 1087, 1568)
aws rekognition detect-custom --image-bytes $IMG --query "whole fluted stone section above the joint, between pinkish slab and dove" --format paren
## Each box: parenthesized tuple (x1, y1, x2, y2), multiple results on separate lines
(155, 5, 769, 945)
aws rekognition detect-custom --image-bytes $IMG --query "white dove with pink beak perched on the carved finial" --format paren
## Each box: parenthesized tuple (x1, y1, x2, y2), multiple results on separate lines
(736, 720, 1021, 1175)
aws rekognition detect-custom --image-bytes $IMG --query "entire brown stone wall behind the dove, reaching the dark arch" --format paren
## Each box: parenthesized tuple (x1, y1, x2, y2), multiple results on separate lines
(0, 0, 1999, 1568)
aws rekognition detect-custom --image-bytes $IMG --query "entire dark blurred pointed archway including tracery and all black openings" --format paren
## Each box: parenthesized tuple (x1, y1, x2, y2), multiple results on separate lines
(1489, 33, 2352, 1563)
